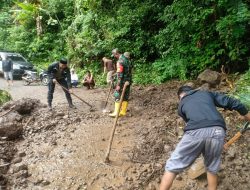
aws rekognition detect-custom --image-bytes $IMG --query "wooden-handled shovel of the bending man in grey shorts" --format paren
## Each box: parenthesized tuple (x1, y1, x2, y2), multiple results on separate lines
(188, 122, 250, 179)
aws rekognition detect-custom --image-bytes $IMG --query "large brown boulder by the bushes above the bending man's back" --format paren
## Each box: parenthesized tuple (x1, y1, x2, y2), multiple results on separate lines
(197, 69, 221, 87)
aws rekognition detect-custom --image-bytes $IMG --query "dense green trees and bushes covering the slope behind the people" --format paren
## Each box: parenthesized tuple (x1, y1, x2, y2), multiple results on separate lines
(0, 0, 250, 84)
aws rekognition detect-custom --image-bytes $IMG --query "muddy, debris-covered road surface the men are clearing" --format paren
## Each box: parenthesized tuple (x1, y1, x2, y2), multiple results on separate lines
(0, 80, 250, 190)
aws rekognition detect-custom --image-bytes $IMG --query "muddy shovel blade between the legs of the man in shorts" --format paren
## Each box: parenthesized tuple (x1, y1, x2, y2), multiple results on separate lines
(188, 159, 206, 179)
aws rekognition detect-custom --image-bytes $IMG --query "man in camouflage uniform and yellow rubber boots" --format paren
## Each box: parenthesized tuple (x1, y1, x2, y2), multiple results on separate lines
(109, 48, 132, 117)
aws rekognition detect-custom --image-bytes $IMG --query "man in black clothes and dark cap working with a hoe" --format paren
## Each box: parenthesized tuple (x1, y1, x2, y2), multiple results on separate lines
(48, 58, 76, 110)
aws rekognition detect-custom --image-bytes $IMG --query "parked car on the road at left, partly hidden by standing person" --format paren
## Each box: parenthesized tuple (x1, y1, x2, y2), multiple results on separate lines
(0, 51, 34, 79)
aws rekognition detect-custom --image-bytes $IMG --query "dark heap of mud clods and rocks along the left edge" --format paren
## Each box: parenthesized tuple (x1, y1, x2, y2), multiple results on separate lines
(0, 99, 44, 189)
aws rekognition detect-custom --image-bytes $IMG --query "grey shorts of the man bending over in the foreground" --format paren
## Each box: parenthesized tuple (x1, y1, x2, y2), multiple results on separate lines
(165, 127, 225, 174)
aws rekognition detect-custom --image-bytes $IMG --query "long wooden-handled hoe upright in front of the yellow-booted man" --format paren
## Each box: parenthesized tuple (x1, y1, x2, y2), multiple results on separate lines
(105, 81, 129, 163)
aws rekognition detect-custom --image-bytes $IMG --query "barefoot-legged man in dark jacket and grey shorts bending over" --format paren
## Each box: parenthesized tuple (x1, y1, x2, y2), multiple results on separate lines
(160, 86, 250, 190)
